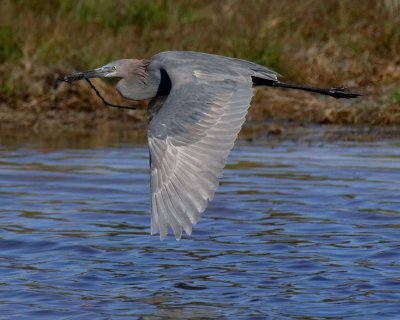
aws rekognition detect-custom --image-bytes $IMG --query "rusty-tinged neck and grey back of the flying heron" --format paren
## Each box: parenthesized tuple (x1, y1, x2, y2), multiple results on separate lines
(117, 51, 278, 100)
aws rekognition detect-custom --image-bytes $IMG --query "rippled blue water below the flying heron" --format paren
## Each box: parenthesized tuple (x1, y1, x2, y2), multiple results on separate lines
(0, 142, 400, 319)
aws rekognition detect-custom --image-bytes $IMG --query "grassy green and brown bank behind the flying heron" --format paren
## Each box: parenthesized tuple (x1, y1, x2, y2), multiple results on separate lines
(0, 0, 400, 140)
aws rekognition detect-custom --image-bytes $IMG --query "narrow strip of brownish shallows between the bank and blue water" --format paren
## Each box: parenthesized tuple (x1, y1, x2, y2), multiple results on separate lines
(0, 121, 400, 150)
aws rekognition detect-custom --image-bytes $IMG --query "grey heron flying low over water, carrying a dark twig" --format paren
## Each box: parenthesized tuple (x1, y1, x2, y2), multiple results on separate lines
(63, 51, 360, 240)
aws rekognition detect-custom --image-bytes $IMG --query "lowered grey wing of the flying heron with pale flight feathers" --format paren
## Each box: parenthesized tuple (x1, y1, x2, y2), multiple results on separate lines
(148, 68, 252, 239)
